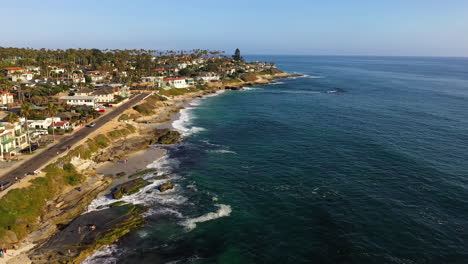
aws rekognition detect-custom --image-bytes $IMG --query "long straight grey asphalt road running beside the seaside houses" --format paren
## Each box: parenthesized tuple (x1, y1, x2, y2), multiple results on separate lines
(0, 93, 148, 186)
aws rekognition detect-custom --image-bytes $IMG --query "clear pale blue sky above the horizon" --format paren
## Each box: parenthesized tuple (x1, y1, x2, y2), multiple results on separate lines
(0, 0, 468, 56)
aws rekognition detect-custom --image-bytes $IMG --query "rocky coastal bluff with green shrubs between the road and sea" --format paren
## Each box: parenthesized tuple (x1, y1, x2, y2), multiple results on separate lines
(0, 69, 297, 263)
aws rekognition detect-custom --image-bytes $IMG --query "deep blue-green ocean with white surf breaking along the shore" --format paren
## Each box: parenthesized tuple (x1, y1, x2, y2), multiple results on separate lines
(86, 56, 468, 264)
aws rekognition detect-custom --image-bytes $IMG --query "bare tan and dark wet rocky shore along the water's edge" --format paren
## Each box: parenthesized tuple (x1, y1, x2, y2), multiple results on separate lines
(2, 70, 300, 263)
